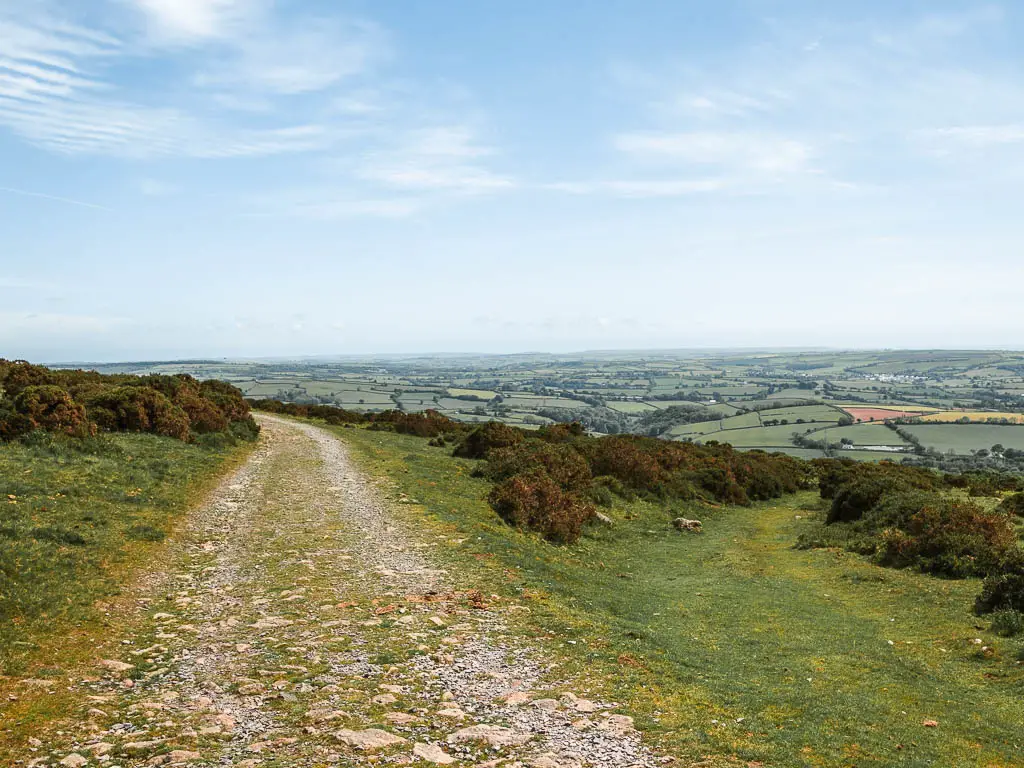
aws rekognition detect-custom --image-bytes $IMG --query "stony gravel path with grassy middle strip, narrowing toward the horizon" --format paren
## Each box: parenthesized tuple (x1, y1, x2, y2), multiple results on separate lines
(22, 417, 669, 768)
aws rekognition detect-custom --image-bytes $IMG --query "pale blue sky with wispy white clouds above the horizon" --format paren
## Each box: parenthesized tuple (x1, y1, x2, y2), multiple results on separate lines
(0, 0, 1024, 361)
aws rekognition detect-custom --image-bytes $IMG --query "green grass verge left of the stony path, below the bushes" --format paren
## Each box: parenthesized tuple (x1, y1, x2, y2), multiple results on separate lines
(0, 434, 252, 754)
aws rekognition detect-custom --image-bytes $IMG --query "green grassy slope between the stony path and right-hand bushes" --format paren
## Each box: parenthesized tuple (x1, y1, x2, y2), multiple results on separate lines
(337, 429, 1024, 768)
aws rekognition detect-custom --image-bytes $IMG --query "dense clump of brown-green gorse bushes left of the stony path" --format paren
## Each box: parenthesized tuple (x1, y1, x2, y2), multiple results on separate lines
(0, 359, 259, 441)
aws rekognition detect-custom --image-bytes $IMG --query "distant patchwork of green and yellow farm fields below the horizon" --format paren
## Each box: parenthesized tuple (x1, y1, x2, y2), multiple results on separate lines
(81, 351, 1024, 471)
